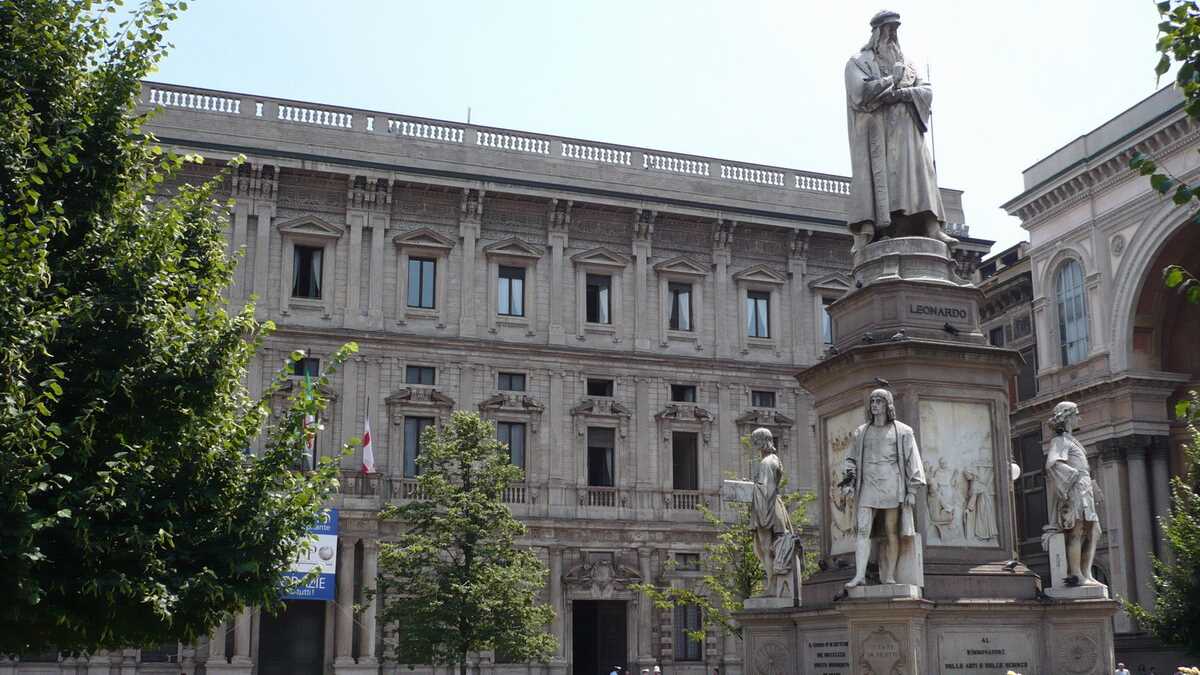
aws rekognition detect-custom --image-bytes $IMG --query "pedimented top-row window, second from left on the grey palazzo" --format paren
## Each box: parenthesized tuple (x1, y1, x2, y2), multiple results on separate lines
(392, 227, 455, 328)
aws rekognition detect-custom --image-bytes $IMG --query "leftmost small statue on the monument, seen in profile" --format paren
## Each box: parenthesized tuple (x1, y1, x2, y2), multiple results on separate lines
(750, 428, 796, 598)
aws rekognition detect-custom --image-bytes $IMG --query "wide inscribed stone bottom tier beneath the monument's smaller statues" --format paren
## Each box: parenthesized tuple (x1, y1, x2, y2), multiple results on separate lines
(736, 586, 1117, 675)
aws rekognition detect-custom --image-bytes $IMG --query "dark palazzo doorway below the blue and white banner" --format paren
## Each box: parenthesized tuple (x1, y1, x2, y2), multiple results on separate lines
(258, 601, 325, 675)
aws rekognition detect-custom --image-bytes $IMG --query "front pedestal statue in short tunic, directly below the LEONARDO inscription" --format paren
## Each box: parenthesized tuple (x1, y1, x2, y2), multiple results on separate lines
(841, 389, 925, 589)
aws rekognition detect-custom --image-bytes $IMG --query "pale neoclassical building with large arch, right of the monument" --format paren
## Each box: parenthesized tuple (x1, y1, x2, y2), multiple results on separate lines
(1003, 88, 1200, 673)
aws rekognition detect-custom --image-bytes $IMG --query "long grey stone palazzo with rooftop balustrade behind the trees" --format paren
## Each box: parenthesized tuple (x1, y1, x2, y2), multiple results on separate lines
(0, 83, 990, 675)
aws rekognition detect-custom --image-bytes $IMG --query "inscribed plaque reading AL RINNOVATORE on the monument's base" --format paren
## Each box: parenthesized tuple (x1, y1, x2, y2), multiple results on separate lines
(937, 628, 1040, 675)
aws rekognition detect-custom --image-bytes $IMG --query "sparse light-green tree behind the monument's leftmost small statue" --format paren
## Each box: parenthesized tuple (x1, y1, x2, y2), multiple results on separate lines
(634, 437, 817, 640)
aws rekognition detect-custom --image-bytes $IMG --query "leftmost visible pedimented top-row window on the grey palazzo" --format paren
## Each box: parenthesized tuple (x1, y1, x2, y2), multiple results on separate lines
(276, 216, 344, 318)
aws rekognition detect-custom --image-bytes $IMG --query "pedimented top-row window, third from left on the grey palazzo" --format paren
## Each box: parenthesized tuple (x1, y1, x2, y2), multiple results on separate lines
(484, 237, 544, 335)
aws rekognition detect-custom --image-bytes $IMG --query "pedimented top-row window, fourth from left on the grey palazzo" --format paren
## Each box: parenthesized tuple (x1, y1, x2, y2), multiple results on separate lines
(571, 246, 629, 342)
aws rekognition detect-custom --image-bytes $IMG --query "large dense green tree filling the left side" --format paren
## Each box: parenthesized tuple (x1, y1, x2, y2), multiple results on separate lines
(0, 0, 350, 653)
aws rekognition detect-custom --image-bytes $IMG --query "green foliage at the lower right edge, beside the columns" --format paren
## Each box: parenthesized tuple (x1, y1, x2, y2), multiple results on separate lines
(1126, 392, 1200, 655)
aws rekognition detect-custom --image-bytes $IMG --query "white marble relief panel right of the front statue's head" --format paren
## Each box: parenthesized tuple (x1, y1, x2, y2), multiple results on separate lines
(920, 399, 1007, 546)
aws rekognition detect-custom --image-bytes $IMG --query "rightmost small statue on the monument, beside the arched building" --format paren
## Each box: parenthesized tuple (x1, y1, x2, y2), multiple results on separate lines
(1046, 401, 1103, 586)
